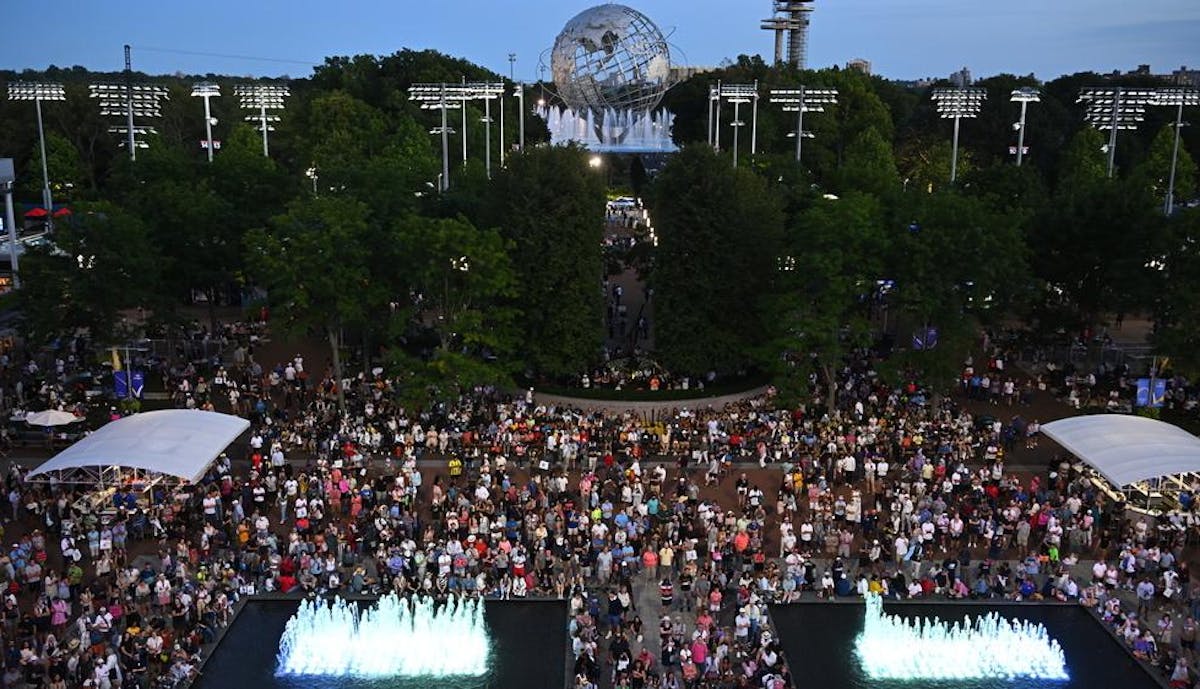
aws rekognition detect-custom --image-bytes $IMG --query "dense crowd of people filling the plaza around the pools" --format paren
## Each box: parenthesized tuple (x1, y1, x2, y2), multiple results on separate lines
(0, 326, 1200, 689)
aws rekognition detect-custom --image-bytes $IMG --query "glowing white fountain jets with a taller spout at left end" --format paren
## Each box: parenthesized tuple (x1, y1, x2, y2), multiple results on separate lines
(854, 593, 1069, 681)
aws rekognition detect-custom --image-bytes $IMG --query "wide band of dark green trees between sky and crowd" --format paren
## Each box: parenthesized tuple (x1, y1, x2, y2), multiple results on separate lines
(0, 50, 1200, 399)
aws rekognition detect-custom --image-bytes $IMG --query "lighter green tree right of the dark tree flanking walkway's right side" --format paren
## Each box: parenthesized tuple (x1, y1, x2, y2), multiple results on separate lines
(768, 192, 888, 409)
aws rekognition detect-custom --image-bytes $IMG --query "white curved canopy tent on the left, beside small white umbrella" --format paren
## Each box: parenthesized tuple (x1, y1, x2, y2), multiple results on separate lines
(28, 409, 250, 483)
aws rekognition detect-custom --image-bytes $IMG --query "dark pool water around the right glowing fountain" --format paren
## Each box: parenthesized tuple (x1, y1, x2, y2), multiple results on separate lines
(770, 603, 1159, 689)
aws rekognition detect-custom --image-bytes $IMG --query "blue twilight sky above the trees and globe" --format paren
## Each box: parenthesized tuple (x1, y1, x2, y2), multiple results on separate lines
(0, 0, 1200, 80)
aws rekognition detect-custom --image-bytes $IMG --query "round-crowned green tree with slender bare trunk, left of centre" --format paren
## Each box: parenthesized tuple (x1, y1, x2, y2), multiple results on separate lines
(246, 196, 379, 409)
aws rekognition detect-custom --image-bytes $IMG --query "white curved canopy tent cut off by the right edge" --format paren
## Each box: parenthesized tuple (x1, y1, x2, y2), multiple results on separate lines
(1042, 414, 1200, 486)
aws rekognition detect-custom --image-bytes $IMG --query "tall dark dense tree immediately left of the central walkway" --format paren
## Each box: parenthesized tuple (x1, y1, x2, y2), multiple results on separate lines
(486, 146, 605, 377)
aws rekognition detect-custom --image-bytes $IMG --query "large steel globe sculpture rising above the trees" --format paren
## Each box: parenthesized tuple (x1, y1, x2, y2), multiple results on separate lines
(550, 5, 672, 143)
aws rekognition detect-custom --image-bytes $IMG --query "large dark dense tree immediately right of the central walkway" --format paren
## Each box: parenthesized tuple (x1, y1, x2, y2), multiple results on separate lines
(652, 145, 784, 375)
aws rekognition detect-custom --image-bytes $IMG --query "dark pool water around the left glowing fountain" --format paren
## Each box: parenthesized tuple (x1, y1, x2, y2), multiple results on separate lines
(193, 600, 566, 689)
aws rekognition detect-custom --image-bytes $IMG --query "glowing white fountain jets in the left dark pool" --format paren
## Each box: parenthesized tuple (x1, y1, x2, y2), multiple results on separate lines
(275, 594, 490, 679)
